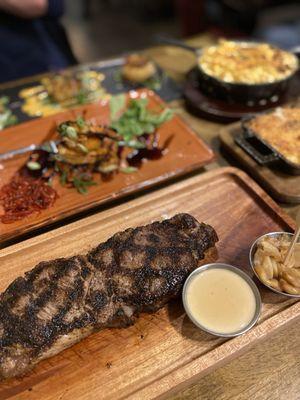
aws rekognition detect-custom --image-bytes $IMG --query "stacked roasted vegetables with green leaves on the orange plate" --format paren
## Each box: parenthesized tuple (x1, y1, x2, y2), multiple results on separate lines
(27, 95, 173, 194)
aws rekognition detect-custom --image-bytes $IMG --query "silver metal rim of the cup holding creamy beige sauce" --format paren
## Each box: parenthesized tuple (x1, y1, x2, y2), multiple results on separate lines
(182, 263, 261, 338)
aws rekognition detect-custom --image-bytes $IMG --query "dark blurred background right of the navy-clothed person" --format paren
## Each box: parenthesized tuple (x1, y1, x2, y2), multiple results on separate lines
(63, 0, 300, 62)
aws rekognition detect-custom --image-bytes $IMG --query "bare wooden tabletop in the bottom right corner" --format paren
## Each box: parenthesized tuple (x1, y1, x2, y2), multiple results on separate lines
(170, 320, 300, 400)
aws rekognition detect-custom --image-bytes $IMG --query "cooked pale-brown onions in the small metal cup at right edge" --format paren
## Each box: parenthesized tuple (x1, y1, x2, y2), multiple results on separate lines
(254, 235, 300, 295)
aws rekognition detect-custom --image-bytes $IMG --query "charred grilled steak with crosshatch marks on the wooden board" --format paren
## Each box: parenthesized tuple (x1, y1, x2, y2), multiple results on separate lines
(0, 214, 218, 379)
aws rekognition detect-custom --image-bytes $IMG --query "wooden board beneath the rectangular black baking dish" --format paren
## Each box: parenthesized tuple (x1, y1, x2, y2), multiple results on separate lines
(219, 122, 300, 204)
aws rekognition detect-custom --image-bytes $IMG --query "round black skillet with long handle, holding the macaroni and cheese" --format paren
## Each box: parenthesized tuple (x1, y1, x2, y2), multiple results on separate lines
(157, 37, 300, 106)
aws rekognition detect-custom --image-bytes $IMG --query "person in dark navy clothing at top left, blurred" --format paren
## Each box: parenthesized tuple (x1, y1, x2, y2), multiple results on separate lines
(0, 0, 76, 82)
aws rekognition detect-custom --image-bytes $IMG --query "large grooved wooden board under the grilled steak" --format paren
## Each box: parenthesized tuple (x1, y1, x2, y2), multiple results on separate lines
(0, 167, 300, 400)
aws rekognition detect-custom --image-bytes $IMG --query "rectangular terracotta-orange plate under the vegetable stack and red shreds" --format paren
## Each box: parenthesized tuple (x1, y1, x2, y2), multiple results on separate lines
(0, 89, 214, 243)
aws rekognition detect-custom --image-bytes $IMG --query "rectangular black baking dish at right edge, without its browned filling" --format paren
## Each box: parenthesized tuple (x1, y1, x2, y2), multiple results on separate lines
(235, 112, 300, 175)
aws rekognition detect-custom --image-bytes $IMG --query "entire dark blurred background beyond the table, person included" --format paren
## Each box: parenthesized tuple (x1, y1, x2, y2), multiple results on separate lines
(0, 0, 300, 82)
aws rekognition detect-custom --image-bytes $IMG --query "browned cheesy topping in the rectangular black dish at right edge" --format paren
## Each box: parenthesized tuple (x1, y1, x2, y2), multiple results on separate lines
(245, 107, 300, 165)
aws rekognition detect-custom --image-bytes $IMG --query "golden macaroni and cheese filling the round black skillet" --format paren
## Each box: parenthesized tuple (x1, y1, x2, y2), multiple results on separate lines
(198, 40, 298, 85)
